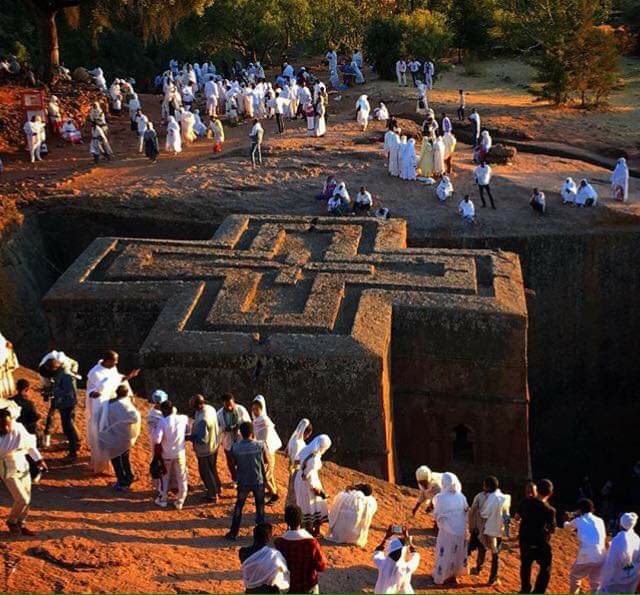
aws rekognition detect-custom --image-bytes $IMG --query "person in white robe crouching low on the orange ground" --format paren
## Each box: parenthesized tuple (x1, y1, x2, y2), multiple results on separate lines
(327, 484, 378, 548)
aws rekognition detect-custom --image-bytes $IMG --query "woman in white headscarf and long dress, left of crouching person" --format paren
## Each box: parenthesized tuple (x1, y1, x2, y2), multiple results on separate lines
(295, 434, 331, 536)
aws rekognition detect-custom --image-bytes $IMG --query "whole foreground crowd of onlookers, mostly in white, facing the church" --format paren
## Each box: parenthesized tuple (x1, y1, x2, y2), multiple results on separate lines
(0, 335, 640, 593)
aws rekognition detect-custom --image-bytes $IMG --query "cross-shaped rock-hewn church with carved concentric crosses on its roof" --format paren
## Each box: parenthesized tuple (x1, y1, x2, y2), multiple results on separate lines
(44, 215, 529, 481)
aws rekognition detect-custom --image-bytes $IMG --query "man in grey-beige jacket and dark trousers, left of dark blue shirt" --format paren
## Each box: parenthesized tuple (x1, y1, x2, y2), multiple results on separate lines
(189, 395, 220, 502)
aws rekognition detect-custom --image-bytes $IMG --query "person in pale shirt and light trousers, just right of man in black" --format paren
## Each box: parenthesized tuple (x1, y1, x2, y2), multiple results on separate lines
(562, 498, 607, 593)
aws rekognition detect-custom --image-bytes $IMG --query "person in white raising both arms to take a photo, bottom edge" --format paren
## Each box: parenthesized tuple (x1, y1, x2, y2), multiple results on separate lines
(373, 526, 420, 593)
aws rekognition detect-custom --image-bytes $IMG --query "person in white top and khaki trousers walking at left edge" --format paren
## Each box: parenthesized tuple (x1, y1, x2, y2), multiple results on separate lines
(0, 409, 47, 537)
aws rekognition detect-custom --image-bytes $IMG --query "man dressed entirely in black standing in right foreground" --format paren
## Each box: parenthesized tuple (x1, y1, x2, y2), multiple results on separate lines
(518, 479, 556, 593)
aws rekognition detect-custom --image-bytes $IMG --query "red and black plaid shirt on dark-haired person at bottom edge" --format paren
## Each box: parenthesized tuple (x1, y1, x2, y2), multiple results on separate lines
(274, 537, 327, 593)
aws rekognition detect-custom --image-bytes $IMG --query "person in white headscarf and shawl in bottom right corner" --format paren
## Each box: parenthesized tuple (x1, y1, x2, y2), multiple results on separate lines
(598, 512, 640, 593)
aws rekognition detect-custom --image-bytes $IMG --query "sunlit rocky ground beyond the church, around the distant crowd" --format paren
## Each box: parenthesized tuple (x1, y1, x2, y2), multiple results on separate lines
(0, 60, 640, 238)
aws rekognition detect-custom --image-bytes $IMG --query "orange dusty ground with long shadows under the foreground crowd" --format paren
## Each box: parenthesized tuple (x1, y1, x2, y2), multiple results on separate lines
(0, 370, 576, 593)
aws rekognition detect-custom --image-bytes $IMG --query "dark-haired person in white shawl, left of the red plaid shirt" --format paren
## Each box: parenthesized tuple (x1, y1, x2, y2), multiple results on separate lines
(238, 523, 290, 593)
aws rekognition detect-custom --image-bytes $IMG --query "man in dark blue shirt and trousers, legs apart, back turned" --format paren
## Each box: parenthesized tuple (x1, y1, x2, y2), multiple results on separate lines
(225, 421, 269, 541)
